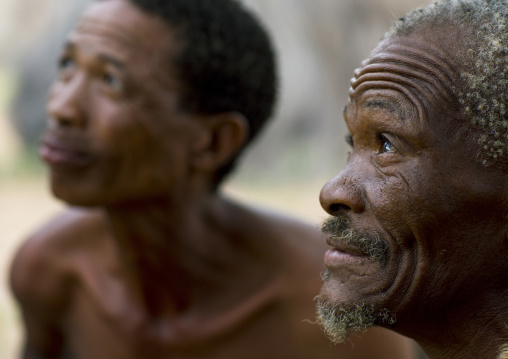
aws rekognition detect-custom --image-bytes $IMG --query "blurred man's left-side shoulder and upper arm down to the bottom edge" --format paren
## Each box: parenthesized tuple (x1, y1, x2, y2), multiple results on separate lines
(10, 209, 110, 358)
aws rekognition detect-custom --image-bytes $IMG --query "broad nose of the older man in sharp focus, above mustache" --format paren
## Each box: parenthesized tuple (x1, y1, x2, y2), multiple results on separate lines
(319, 164, 365, 216)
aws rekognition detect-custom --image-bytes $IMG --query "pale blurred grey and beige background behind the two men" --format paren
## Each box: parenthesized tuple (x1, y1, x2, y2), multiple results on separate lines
(0, 0, 430, 359)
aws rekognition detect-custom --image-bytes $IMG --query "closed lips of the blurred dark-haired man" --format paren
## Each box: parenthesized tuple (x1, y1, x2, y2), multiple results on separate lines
(39, 138, 92, 168)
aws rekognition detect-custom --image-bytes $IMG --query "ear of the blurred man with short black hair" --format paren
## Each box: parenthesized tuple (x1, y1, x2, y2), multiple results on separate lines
(192, 112, 249, 171)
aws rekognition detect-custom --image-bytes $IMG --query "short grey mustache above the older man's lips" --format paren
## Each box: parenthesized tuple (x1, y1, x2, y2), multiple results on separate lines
(321, 215, 388, 264)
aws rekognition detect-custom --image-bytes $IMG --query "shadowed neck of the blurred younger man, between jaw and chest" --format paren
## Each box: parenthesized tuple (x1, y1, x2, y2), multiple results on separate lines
(102, 194, 274, 315)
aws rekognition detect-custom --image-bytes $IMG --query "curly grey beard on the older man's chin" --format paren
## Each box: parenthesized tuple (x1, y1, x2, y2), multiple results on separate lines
(316, 294, 395, 343)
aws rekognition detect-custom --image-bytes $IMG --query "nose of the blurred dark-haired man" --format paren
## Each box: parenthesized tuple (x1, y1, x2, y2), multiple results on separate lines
(47, 75, 86, 127)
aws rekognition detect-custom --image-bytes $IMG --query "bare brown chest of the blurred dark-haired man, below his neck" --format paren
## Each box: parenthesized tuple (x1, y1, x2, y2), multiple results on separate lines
(65, 271, 299, 359)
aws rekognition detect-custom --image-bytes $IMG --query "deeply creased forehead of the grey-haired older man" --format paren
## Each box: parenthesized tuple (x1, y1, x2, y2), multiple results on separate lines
(349, 33, 459, 126)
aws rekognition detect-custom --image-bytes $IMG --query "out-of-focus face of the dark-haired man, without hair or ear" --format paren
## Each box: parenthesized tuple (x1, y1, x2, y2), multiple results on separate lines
(40, 0, 204, 205)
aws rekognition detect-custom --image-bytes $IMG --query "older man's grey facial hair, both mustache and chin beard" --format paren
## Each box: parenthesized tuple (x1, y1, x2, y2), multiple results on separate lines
(316, 215, 395, 343)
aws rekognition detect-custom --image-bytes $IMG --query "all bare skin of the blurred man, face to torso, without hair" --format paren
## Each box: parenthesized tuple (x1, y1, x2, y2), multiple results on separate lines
(6, 0, 411, 359)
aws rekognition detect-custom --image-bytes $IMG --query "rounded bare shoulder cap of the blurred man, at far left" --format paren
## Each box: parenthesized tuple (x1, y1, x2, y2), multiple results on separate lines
(10, 209, 104, 310)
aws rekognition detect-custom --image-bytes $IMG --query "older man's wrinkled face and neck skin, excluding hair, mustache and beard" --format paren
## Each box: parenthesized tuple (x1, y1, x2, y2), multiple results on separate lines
(320, 24, 508, 359)
